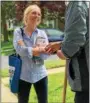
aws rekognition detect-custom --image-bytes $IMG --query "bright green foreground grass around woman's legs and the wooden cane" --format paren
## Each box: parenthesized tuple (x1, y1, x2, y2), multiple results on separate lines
(29, 73, 74, 103)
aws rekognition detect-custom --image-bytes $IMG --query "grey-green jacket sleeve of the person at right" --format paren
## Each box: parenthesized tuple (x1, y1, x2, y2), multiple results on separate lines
(61, 3, 87, 58)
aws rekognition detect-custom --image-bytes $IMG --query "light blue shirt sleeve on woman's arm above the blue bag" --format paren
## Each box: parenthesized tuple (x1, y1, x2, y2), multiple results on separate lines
(13, 28, 33, 58)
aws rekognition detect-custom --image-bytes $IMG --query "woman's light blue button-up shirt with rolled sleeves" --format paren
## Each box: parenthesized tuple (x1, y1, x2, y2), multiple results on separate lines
(13, 28, 48, 83)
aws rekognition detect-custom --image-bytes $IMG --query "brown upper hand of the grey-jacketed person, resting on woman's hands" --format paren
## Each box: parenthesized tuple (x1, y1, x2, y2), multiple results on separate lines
(45, 42, 61, 54)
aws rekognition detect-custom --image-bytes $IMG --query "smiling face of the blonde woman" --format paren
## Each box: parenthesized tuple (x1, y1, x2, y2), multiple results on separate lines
(28, 8, 41, 25)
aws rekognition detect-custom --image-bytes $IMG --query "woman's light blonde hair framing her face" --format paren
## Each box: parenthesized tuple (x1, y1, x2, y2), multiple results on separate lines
(23, 4, 41, 25)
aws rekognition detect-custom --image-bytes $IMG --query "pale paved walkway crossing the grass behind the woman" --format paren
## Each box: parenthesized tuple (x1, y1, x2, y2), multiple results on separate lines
(1, 67, 65, 103)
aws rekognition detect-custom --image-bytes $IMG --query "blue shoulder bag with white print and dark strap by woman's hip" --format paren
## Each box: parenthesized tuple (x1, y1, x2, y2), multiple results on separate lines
(9, 28, 23, 93)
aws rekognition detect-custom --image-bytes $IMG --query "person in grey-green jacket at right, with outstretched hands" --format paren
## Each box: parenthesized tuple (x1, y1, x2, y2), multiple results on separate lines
(46, 1, 89, 103)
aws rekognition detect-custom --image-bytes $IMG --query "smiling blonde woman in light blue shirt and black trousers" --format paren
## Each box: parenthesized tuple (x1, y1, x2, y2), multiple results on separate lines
(13, 5, 48, 103)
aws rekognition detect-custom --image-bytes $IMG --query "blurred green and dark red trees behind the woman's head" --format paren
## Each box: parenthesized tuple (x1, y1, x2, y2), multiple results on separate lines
(1, 1, 65, 42)
